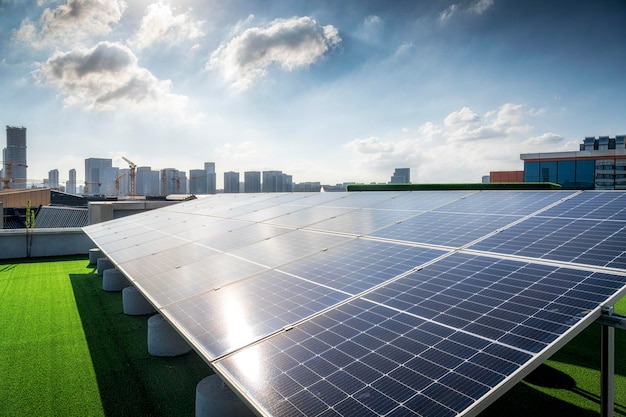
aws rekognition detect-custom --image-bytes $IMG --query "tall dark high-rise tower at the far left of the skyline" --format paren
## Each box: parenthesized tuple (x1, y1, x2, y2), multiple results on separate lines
(2, 126, 27, 188)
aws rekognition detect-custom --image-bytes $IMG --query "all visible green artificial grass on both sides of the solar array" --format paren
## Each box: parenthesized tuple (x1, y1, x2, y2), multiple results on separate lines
(0, 257, 626, 417)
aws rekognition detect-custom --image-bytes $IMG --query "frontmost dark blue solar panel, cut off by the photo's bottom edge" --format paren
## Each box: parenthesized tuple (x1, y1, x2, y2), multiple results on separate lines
(216, 300, 531, 416)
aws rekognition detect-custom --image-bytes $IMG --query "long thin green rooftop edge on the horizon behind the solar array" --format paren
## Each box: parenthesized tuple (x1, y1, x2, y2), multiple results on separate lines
(346, 182, 561, 192)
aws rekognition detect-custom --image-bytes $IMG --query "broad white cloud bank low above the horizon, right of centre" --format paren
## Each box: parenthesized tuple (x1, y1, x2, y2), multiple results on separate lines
(344, 103, 544, 182)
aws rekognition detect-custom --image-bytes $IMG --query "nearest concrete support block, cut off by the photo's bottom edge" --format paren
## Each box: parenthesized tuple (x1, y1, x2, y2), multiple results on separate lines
(196, 374, 254, 417)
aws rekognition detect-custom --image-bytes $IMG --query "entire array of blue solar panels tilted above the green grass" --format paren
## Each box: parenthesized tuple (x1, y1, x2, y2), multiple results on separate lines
(85, 191, 626, 416)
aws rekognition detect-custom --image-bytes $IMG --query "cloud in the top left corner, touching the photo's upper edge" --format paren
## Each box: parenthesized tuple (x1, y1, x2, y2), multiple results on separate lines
(13, 0, 126, 46)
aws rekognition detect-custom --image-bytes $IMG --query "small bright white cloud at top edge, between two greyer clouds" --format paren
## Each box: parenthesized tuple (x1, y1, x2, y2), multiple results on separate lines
(131, 2, 204, 49)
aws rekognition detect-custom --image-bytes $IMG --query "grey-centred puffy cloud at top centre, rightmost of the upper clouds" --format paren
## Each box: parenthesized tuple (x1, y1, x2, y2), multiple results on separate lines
(207, 17, 341, 90)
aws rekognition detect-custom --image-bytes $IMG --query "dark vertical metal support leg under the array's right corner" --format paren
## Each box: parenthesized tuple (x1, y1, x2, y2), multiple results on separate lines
(600, 325, 615, 417)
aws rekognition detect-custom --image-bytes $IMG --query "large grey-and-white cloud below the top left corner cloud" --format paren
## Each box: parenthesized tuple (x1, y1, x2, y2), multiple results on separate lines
(35, 42, 186, 109)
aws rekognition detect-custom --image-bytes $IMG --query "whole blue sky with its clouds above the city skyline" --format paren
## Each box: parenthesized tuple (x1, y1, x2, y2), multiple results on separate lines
(0, 0, 626, 186)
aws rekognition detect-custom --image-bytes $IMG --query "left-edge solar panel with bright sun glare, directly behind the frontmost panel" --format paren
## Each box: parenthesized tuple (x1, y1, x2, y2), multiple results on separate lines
(163, 271, 349, 359)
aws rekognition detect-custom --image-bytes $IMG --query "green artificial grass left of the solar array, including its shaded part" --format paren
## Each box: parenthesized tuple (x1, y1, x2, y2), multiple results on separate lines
(0, 257, 212, 416)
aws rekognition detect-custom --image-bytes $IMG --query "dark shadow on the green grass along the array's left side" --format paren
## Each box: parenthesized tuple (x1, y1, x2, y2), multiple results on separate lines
(70, 271, 212, 416)
